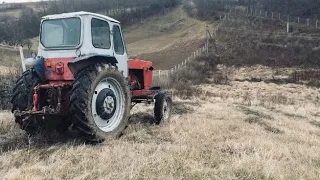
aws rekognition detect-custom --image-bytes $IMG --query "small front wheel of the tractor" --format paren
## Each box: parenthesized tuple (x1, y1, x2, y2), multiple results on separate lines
(154, 92, 172, 124)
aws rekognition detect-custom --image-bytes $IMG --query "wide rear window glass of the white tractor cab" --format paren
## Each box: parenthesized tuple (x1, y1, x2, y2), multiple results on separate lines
(41, 18, 81, 48)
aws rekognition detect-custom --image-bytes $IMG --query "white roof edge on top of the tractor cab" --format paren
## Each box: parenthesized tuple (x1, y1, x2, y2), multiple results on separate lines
(42, 11, 120, 24)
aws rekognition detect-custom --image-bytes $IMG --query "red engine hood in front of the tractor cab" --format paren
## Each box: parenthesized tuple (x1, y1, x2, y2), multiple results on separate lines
(128, 59, 153, 90)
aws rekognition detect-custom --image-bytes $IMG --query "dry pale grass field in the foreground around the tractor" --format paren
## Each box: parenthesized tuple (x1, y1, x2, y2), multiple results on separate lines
(0, 67, 320, 179)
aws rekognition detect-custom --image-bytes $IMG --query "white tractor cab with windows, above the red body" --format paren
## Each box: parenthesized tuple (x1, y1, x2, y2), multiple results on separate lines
(38, 12, 128, 77)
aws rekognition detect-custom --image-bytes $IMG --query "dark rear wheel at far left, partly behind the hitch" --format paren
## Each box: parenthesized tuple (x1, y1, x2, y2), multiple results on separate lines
(11, 69, 40, 135)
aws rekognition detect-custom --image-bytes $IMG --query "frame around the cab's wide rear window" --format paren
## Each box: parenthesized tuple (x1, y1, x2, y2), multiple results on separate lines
(39, 16, 83, 50)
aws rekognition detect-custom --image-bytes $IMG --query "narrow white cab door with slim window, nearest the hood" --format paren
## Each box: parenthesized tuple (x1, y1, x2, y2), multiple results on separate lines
(112, 24, 128, 77)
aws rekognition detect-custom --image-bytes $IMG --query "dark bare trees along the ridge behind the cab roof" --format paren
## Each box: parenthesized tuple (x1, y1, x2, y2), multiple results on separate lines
(0, 0, 182, 45)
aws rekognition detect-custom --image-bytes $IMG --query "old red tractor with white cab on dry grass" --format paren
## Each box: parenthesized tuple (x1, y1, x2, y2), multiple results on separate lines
(11, 12, 172, 143)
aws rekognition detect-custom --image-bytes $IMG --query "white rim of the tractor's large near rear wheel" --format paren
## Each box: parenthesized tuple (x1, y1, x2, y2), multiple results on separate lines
(92, 77, 125, 132)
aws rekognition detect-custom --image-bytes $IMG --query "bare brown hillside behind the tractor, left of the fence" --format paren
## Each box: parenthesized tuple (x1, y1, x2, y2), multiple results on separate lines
(124, 7, 210, 69)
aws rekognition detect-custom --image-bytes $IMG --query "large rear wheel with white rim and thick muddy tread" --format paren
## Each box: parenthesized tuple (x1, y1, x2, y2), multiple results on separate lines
(69, 64, 131, 143)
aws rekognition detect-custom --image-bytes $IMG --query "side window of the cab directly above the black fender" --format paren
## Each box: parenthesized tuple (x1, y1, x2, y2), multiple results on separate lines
(91, 18, 111, 49)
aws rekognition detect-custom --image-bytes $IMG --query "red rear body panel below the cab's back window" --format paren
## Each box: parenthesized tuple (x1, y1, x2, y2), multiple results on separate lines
(44, 57, 74, 81)
